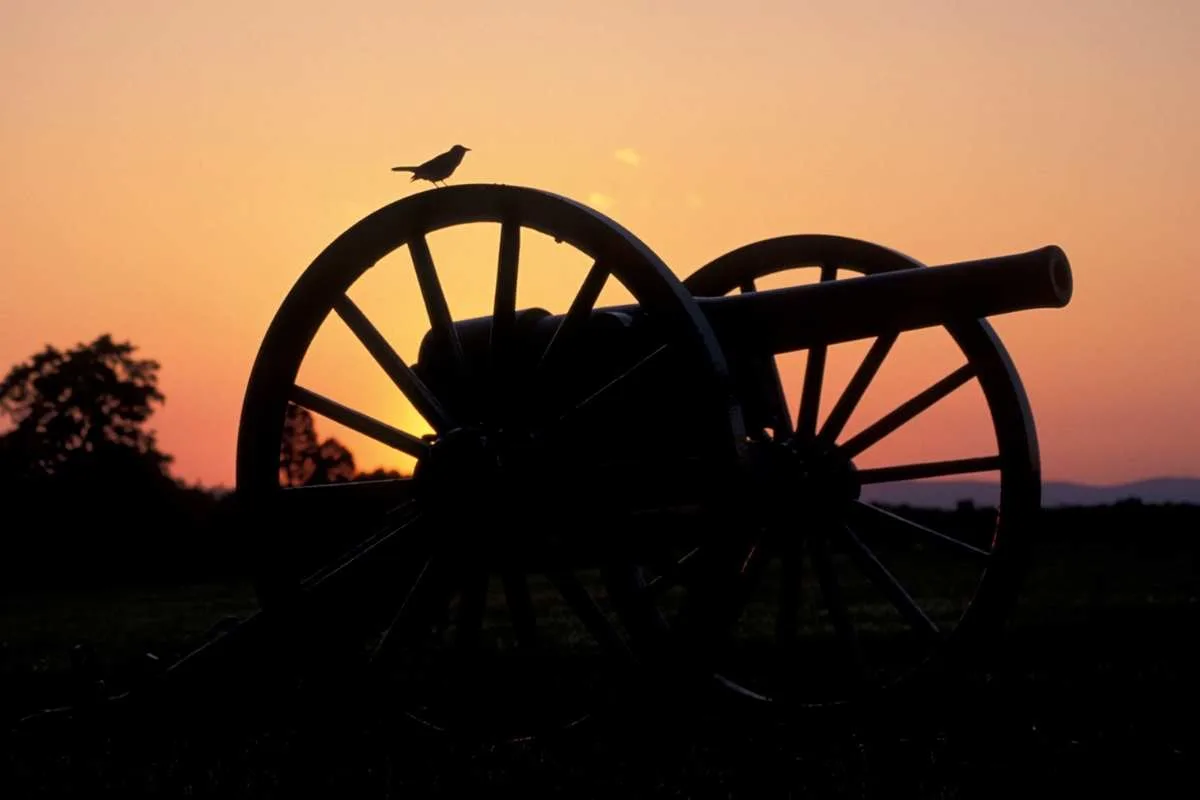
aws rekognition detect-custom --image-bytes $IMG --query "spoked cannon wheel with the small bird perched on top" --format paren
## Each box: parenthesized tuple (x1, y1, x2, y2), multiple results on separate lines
(229, 185, 745, 740)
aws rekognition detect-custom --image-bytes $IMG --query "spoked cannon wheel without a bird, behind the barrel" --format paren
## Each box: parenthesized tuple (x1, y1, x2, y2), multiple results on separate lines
(628, 235, 1040, 708)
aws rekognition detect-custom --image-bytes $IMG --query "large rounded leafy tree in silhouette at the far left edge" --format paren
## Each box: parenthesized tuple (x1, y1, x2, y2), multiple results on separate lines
(0, 333, 172, 476)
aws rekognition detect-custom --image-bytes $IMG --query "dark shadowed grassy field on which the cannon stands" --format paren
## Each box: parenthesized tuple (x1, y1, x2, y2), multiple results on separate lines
(0, 515, 1200, 798)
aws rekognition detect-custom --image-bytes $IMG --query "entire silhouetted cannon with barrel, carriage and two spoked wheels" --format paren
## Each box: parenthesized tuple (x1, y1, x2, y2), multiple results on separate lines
(35, 185, 1072, 736)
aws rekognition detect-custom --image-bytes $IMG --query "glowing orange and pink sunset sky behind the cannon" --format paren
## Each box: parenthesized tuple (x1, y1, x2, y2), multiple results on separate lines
(0, 0, 1200, 486)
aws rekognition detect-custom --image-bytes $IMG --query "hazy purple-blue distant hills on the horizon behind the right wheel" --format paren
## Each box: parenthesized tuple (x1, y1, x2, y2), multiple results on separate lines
(863, 477, 1200, 509)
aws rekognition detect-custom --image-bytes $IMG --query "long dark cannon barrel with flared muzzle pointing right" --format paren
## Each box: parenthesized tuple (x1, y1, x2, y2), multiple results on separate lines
(697, 245, 1073, 353)
